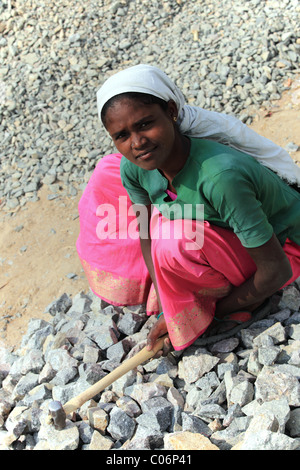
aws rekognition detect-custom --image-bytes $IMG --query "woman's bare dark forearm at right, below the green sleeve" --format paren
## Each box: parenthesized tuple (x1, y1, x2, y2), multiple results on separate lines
(216, 234, 293, 318)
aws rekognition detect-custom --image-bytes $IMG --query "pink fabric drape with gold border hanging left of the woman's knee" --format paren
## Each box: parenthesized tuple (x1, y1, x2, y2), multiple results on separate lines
(76, 154, 158, 313)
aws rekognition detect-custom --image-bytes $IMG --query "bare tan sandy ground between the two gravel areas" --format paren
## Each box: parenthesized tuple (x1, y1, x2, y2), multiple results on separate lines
(0, 79, 300, 349)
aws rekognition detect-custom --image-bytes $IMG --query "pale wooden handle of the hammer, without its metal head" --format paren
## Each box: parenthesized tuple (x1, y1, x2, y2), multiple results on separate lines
(63, 335, 168, 415)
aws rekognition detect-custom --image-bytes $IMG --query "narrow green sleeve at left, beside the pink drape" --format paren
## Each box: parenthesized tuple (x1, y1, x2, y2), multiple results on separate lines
(120, 157, 151, 205)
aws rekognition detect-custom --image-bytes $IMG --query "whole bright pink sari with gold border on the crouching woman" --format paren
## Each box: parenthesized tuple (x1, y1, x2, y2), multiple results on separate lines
(76, 154, 300, 350)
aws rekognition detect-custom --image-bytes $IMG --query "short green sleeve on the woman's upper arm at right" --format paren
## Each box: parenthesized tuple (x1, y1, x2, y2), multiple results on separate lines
(206, 169, 273, 248)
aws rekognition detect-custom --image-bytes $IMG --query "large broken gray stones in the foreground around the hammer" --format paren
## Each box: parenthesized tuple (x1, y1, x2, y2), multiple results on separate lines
(0, 284, 300, 451)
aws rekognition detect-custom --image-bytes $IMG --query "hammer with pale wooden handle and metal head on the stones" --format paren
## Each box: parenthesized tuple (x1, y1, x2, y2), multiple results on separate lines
(47, 335, 168, 430)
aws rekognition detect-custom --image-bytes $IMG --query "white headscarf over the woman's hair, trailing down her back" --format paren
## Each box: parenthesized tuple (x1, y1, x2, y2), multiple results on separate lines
(97, 64, 300, 186)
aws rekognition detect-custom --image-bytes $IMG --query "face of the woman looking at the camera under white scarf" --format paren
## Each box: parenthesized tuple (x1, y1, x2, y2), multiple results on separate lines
(105, 98, 178, 170)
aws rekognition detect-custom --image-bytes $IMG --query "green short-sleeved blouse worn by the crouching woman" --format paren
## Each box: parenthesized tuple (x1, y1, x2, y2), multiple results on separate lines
(121, 138, 300, 248)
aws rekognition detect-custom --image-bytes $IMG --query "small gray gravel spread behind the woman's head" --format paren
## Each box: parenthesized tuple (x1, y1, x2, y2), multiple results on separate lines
(0, 0, 300, 211)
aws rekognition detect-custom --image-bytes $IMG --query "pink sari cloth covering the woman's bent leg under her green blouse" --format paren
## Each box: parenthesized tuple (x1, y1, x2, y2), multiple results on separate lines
(152, 214, 300, 349)
